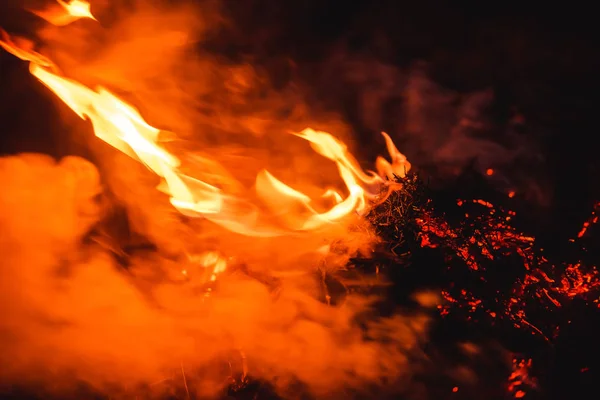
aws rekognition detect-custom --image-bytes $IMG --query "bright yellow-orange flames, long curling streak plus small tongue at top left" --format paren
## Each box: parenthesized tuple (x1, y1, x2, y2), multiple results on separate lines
(0, 17, 410, 237)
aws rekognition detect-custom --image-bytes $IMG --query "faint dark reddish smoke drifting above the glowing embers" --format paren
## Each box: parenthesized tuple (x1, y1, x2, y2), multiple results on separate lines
(305, 45, 551, 205)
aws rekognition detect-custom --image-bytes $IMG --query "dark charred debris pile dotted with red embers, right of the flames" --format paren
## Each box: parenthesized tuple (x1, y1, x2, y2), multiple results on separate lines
(358, 174, 600, 398)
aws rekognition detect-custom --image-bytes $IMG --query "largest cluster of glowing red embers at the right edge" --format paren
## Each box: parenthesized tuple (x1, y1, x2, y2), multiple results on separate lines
(417, 183, 600, 340)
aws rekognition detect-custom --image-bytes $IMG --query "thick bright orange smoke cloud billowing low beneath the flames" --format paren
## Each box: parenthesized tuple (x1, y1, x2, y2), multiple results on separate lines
(0, 155, 436, 395)
